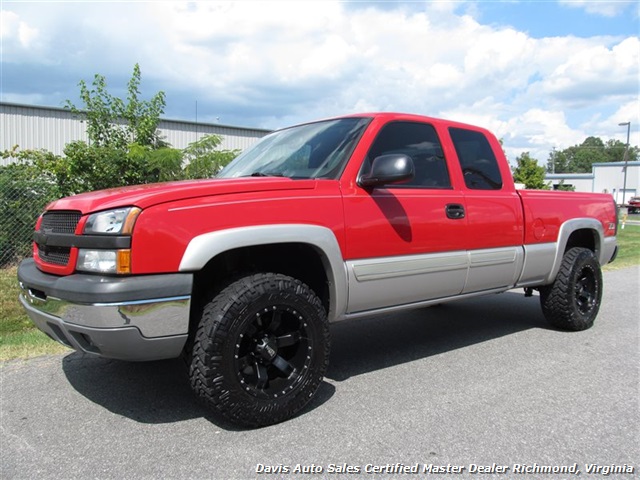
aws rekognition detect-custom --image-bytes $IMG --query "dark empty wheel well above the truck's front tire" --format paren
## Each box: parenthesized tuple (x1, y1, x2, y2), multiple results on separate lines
(189, 243, 330, 342)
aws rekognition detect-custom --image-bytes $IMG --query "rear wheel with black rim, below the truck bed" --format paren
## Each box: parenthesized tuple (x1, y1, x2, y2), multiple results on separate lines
(540, 247, 602, 331)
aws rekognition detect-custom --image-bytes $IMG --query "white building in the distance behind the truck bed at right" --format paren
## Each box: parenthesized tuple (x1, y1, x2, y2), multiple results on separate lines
(545, 162, 640, 204)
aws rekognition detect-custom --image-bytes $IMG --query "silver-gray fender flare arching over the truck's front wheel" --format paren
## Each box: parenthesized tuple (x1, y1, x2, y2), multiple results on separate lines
(179, 224, 348, 321)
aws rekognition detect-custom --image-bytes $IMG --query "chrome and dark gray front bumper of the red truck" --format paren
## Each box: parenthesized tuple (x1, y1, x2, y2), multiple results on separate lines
(18, 260, 193, 361)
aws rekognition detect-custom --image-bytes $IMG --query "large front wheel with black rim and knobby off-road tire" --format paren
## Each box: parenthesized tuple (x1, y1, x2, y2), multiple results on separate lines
(189, 273, 330, 427)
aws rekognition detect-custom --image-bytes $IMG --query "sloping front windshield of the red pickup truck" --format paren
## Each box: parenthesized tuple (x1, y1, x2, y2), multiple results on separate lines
(218, 117, 371, 179)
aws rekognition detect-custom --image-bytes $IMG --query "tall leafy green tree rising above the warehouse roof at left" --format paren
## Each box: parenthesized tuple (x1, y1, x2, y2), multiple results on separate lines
(56, 64, 182, 191)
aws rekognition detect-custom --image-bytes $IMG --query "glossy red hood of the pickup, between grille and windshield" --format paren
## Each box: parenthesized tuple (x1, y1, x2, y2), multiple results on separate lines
(47, 177, 316, 214)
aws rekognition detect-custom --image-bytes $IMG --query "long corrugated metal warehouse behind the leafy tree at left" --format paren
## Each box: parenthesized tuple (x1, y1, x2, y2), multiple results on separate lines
(0, 102, 270, 164)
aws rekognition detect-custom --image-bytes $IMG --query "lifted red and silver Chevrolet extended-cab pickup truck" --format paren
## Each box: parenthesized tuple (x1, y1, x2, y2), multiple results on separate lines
(18, 113, 617, 426)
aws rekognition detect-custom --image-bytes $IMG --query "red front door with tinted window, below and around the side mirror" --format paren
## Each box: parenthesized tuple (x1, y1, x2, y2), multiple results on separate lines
(342, 120, 468, 313)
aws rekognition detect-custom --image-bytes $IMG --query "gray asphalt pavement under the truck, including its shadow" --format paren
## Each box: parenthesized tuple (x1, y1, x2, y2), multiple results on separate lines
(0, 267, 640, 479)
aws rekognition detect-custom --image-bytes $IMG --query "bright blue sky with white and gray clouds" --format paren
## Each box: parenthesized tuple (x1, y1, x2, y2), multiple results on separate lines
(0, 0, 640, 164)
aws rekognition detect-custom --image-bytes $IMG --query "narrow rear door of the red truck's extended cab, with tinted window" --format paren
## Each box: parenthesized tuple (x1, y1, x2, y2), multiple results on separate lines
(448, 126, 524, 293)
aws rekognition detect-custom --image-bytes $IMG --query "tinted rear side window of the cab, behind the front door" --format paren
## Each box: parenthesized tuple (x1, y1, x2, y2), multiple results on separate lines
(449, 127, 503, 190)
